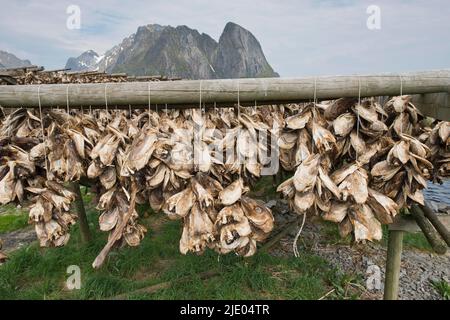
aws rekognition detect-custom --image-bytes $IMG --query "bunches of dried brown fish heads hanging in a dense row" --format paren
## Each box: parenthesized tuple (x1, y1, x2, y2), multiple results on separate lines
(0, 96, 450, 267)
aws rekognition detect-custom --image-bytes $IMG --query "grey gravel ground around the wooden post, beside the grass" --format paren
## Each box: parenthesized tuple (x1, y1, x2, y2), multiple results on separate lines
(268, 200, 450, 300)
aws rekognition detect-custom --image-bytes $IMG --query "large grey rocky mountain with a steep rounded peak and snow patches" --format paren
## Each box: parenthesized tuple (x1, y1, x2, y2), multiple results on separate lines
(66, 22, 279, 79)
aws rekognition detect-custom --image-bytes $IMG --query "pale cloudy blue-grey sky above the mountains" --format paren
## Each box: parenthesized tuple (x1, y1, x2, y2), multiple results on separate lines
(0, 0, 450, 77)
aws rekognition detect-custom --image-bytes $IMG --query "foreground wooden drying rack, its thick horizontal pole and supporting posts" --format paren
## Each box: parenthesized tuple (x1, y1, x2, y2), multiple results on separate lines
(0, 69, 450, 299)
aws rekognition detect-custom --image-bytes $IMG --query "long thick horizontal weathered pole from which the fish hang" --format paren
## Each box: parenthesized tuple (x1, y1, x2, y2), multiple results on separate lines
(0, 69, 450, 109)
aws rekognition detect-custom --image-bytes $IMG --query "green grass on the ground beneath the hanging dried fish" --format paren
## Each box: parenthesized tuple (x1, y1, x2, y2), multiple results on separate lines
(0, 192, 358, 299)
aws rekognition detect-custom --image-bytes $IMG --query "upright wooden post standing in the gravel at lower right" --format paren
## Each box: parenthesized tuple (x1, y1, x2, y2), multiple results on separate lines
(384, 230, 403, 300)
